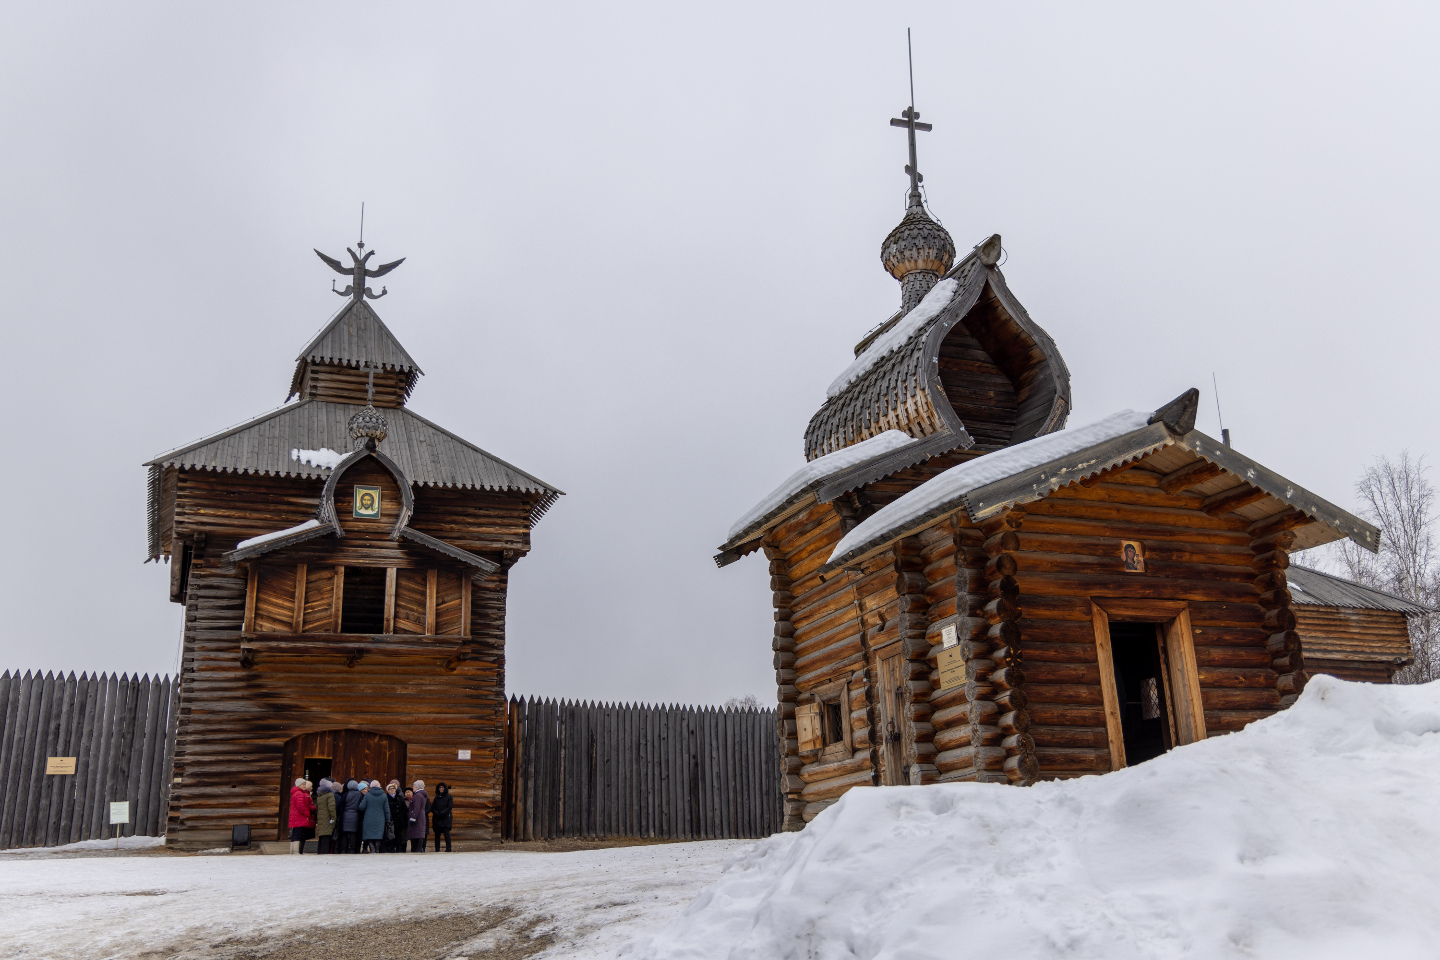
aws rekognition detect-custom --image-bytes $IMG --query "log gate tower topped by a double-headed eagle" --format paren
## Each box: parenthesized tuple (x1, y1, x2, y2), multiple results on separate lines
(147, 243, 562, 848)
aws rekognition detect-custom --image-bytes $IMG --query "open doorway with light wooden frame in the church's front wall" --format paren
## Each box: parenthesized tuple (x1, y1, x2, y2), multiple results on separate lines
(1090, 599, 1205, 770)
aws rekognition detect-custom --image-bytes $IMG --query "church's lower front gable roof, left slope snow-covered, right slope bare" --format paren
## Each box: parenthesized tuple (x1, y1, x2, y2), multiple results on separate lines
(825, 390, 1380, 570)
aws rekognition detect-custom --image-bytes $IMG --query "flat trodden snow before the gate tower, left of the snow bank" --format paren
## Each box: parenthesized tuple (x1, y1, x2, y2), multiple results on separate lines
(0, 841, 750, 960)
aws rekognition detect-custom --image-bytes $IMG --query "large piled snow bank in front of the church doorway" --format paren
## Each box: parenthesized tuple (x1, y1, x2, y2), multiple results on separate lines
(624, 676, 1440, 960)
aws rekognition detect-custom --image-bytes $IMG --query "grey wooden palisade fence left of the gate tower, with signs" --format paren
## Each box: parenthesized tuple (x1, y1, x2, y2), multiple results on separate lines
(0, 671, 179, 849)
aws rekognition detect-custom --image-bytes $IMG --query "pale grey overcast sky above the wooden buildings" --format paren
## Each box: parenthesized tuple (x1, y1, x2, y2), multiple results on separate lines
(0, 1, 1440, 702)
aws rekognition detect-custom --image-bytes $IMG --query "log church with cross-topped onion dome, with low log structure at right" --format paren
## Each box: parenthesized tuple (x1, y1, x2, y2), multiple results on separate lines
(716, 107, 1418, 829)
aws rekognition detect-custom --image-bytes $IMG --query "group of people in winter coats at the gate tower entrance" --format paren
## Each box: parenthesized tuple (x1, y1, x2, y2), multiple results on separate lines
(289, 777, 454, 853)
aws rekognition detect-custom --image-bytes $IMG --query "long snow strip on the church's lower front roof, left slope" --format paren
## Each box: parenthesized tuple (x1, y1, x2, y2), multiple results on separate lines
(829, 410, 1153, 563)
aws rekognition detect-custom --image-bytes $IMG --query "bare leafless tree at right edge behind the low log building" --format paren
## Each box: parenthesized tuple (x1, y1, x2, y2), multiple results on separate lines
(1302, 450, 1440, 684)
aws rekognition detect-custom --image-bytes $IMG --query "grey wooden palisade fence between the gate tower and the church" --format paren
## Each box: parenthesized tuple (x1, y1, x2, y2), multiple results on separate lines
(504, 698, 782, 841)
